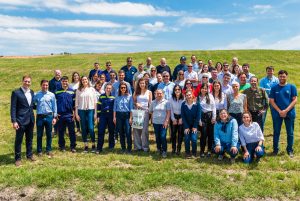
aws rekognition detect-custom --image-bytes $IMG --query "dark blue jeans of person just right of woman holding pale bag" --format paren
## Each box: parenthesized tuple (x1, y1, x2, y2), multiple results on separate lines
(153, 124, 167, 152)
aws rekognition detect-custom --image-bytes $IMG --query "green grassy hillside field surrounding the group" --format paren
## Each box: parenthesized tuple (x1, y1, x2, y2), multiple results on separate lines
(0, 50, 300, 200)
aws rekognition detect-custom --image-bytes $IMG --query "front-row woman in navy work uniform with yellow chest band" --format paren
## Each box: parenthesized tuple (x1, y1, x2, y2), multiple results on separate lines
(96, 83, 115, 154)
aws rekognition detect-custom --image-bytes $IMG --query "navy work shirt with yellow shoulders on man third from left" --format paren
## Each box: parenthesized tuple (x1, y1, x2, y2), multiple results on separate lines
(55, 88, 75, 117)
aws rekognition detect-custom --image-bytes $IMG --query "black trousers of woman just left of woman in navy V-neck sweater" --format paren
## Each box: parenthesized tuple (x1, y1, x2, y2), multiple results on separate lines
(171, 114, 183, 153)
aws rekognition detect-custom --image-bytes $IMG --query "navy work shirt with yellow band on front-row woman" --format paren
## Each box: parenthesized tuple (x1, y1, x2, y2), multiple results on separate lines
(97, 93, 115, 117)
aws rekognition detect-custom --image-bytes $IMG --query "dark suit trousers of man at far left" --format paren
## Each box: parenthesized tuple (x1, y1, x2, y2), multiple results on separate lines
(15, 122, 34, 161)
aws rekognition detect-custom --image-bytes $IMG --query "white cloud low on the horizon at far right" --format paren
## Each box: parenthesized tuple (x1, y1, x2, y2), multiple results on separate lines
(216, 34, 300, 50)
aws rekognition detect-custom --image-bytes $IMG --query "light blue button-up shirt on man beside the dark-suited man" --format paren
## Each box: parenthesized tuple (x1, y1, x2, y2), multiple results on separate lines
(33, 91, 57, 117)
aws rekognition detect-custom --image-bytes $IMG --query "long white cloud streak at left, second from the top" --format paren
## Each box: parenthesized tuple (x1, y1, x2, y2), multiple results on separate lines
(0, 14, 129, 28)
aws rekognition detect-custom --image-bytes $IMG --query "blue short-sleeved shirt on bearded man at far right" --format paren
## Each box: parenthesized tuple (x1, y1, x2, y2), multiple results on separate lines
(269, 84, 298, 118)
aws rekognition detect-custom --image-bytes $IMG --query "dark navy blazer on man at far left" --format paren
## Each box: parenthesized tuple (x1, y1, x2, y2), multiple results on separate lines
(10, 87, 34, 126)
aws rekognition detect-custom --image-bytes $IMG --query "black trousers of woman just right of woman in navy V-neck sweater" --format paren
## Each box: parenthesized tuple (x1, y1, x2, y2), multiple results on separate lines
(200, 112, 214, 152)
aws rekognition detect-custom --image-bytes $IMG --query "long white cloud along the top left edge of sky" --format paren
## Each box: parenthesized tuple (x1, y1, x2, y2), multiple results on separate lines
(0, 0, 181, 17)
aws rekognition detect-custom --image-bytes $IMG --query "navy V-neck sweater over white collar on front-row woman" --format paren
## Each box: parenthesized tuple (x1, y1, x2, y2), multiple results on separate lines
(181, 101, 201, 129)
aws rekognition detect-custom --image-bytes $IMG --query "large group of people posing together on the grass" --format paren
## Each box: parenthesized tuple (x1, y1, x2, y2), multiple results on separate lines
(11, 55, 297, 166)
